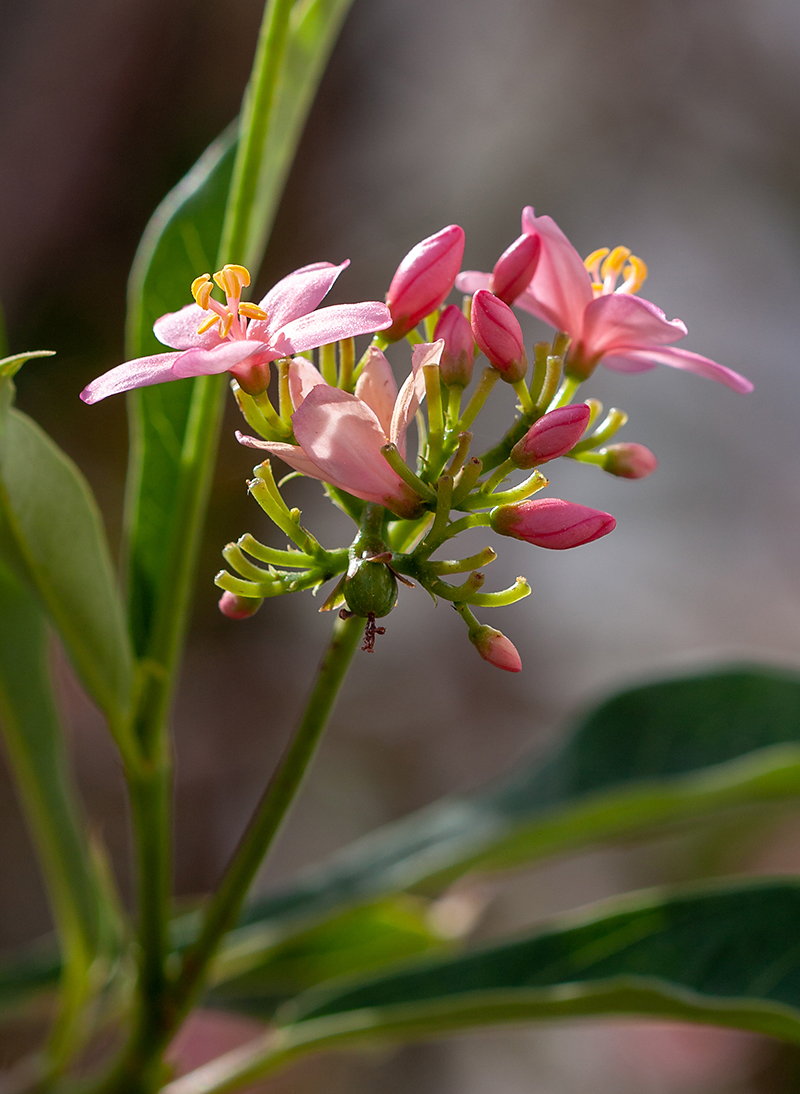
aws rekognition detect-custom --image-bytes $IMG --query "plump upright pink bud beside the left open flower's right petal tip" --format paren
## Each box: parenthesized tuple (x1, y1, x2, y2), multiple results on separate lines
(381, 224, 464, 341)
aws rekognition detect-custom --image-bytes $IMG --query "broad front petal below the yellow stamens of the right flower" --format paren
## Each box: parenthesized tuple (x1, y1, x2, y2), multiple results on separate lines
(582, 292, 686, 358)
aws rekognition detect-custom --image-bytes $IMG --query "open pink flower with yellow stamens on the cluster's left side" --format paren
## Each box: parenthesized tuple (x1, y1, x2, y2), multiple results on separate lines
(81, 261, 392, 403)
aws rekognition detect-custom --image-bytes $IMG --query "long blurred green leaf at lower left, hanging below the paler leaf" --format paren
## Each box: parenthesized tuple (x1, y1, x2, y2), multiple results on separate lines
(0, 555, 118, 1059)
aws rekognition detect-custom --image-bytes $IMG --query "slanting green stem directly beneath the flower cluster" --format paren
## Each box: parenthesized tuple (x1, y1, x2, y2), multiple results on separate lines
(172, 616, 363, 1020)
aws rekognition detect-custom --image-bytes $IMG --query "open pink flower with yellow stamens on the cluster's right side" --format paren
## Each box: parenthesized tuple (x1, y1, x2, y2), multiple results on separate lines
(456, 206, 753, 392)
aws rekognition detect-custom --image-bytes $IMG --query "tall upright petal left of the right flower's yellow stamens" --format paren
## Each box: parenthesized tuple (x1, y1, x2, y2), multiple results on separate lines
(514, 206, 594, 338)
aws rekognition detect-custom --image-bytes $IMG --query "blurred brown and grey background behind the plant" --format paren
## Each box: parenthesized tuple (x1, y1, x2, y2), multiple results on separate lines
(0, 0, 800, 1094)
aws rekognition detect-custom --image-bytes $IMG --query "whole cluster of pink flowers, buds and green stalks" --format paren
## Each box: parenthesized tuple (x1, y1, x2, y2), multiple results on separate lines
(82, 207, 752, 672)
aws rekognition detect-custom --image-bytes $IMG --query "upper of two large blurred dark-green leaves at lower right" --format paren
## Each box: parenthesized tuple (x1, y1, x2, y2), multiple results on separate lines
(234, 667, 800, 923)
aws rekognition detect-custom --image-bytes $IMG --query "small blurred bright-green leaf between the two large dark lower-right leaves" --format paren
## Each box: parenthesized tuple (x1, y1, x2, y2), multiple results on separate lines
(209, 896, 445, 1016)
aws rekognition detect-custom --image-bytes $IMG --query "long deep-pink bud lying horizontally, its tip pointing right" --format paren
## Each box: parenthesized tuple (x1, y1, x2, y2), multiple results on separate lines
(489, 498, 616, 550)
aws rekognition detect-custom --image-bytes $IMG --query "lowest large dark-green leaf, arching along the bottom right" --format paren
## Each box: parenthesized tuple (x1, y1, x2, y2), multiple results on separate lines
(165, 881, 800, 1094)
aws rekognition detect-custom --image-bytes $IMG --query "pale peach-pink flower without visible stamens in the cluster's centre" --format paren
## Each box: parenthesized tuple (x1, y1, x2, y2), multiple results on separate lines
(236, 340, 444, 517)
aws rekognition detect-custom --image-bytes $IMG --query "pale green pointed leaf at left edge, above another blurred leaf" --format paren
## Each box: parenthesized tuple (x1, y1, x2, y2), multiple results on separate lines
(0, 402, 132, 733)
